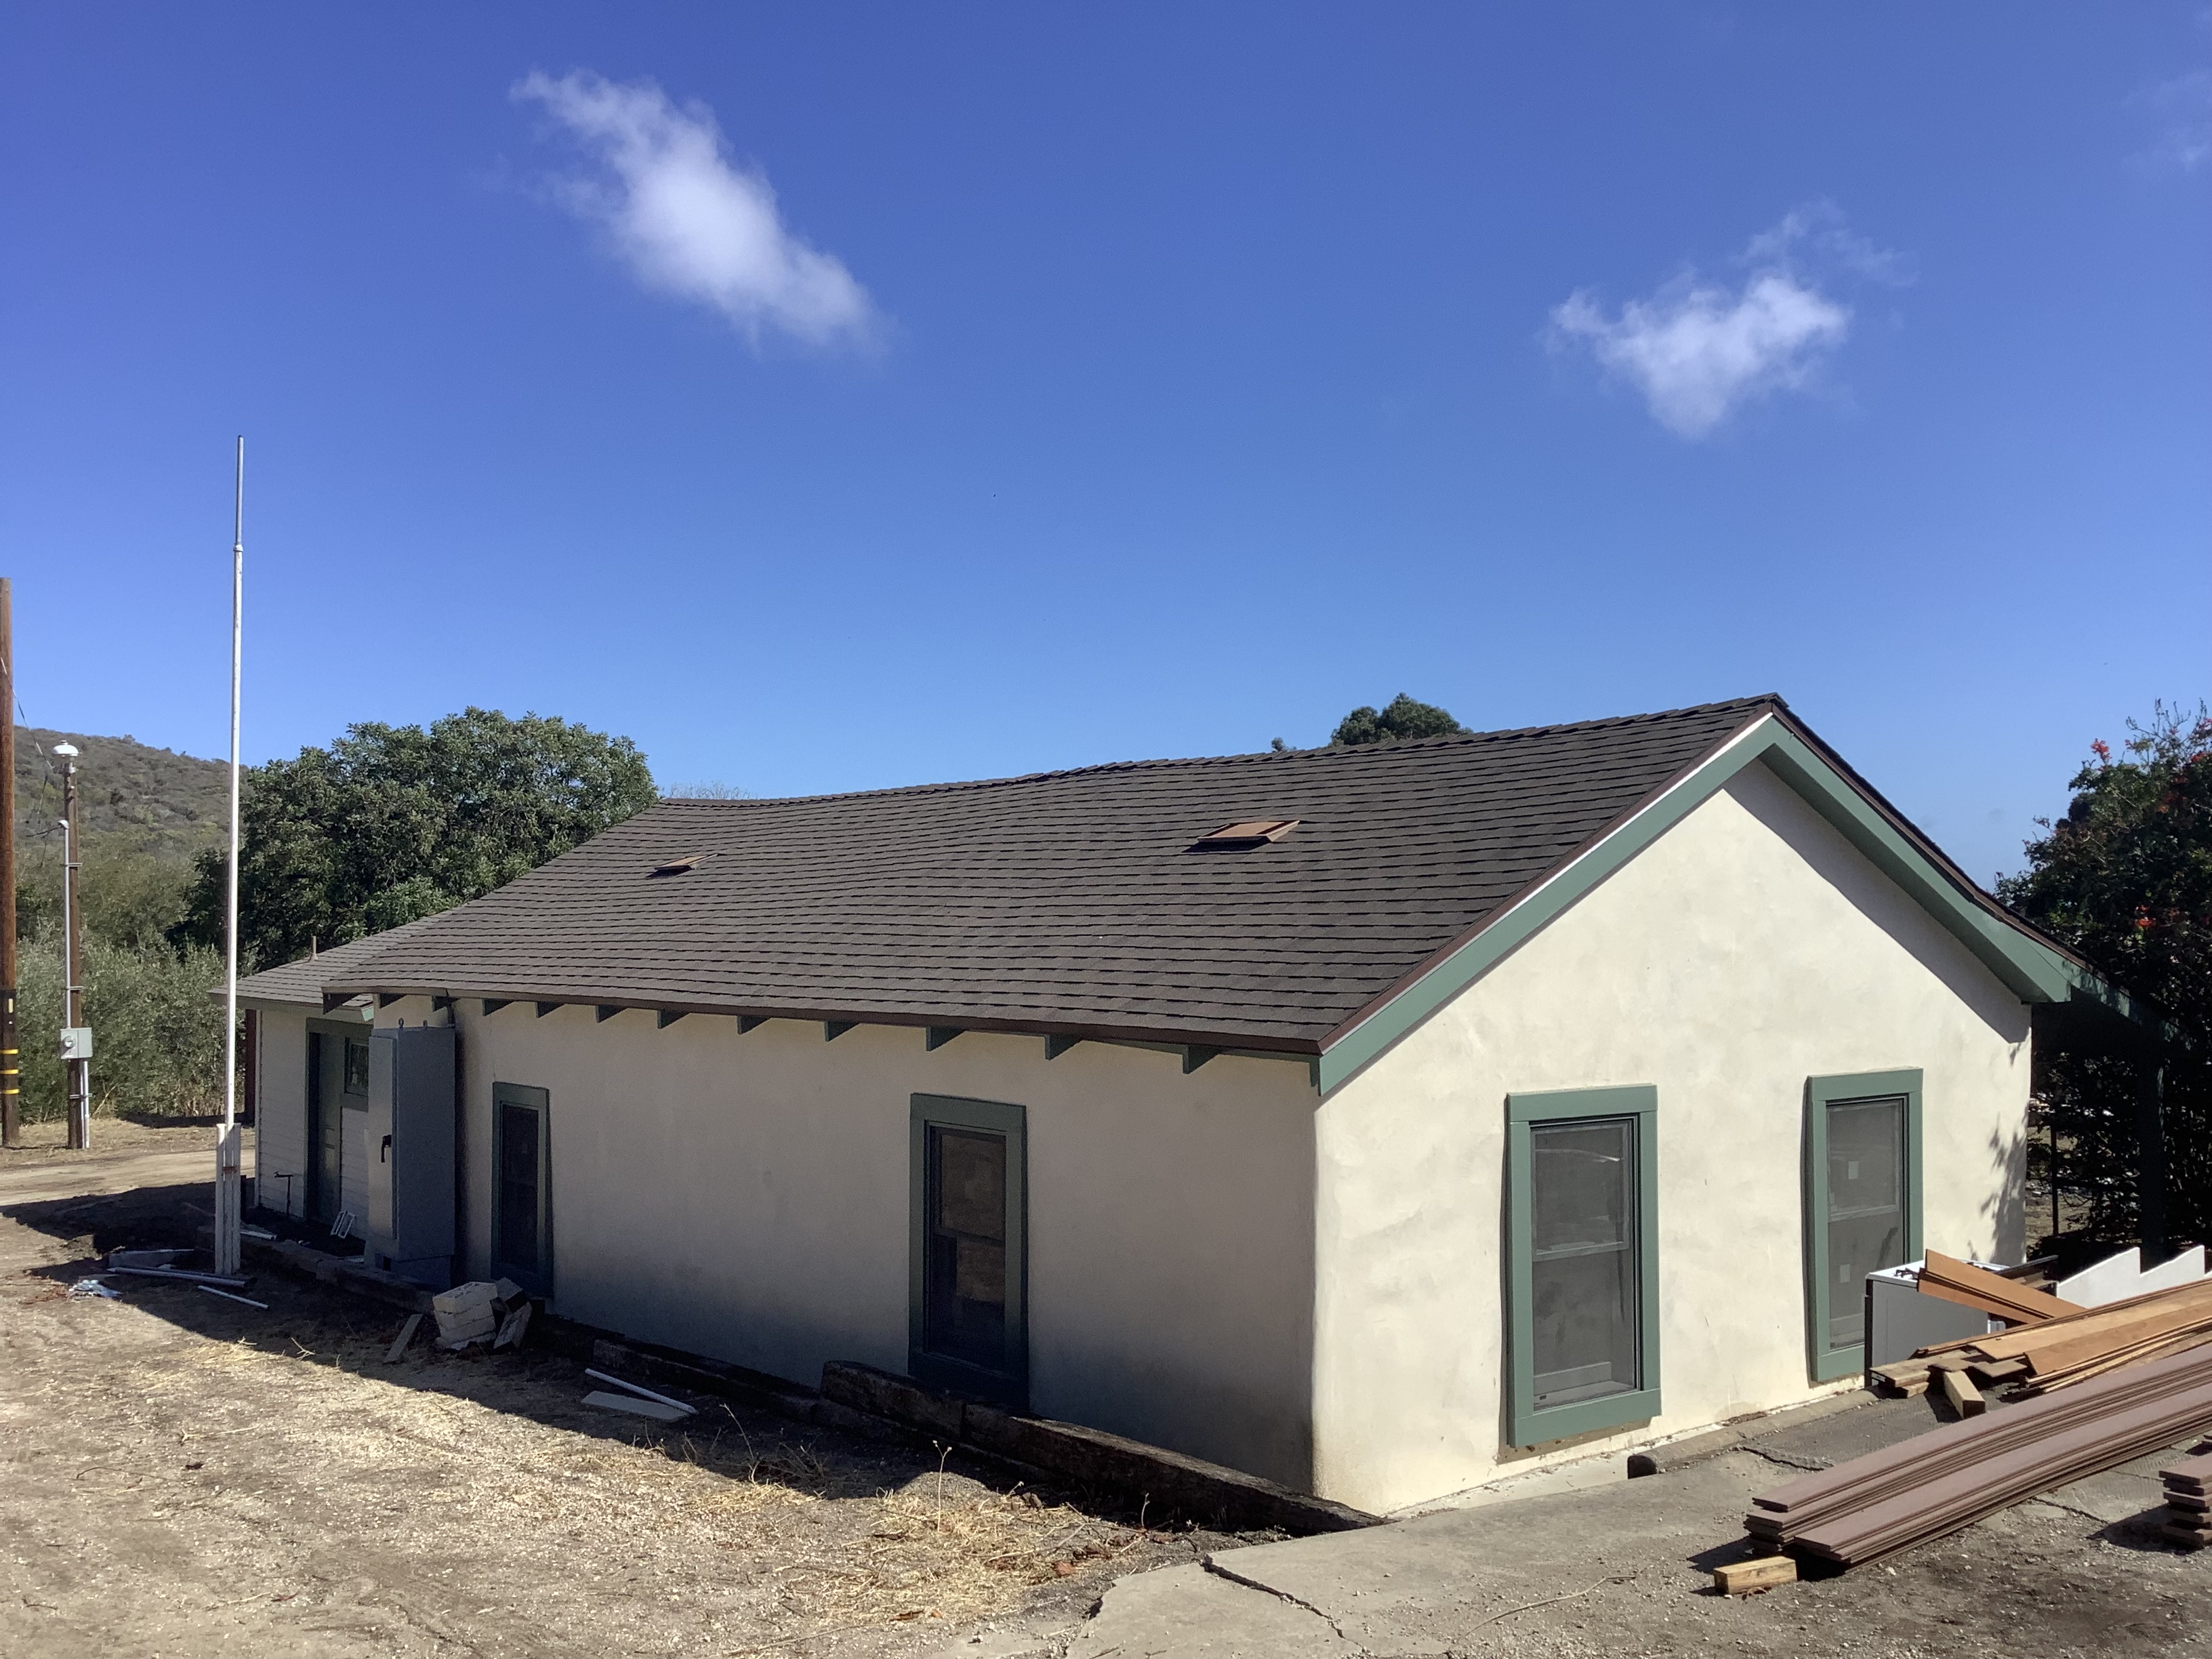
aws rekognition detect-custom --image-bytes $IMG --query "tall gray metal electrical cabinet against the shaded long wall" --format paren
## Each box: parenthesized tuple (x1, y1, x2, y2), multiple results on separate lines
(367, 1026, 458, 1290)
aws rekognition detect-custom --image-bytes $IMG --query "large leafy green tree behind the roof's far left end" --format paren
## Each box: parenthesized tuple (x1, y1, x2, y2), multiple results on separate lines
(170, 708, 655, 964)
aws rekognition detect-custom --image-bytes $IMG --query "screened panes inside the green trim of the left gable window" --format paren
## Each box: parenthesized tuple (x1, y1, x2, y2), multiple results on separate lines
(1528, 1117, 1641, 1411)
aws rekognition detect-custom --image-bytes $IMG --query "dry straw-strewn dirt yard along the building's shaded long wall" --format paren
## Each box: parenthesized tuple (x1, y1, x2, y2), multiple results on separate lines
(0, 1128, 1252, 1659)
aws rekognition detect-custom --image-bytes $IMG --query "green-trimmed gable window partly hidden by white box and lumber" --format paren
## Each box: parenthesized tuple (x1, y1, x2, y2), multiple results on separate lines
(1805, 1071, 1920, 1382)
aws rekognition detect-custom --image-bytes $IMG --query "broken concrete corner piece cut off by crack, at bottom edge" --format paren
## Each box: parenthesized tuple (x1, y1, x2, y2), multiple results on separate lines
(1069, 1551, 1360, 1659)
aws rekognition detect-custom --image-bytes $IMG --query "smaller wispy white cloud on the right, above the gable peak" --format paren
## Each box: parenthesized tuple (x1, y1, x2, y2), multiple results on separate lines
(1551, 203, 1911, 438)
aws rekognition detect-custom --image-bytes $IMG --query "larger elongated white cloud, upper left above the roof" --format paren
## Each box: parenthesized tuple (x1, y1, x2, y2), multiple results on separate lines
(513, 70, 878, 345)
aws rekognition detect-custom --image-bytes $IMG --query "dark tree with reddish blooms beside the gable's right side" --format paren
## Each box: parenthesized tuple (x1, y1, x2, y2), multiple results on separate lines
(1997, 703, 2212, 1241)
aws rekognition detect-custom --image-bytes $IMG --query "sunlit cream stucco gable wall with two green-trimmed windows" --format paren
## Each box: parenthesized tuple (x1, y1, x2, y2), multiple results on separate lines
(1314, 765, 2028, 1511)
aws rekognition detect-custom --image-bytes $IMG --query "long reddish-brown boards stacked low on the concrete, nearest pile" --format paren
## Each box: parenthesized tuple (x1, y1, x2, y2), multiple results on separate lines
(1743, 1347, 2212, 1566)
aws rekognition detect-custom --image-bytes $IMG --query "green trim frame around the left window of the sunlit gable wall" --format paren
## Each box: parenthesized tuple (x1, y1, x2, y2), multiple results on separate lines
(1504, 1084, 1659, 1447)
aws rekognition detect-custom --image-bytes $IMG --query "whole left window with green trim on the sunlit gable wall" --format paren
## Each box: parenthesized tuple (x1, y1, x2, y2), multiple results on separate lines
(1507, 1086, 1659, 1447)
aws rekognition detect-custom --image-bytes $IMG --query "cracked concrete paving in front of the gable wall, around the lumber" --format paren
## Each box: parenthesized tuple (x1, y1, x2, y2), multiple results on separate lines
(1048, 1400, 2212, 1659)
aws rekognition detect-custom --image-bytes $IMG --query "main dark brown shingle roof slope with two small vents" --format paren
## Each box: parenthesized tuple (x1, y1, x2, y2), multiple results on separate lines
(321, 697, 1781, 1053)
